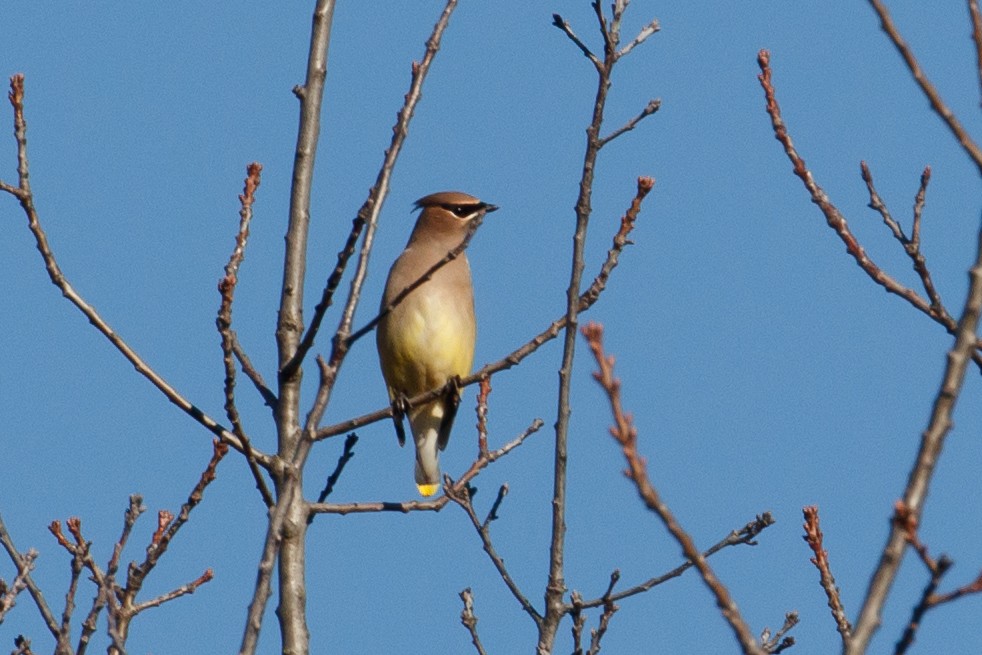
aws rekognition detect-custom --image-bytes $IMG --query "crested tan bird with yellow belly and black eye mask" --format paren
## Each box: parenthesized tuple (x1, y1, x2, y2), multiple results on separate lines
(376, 191, 498, 496)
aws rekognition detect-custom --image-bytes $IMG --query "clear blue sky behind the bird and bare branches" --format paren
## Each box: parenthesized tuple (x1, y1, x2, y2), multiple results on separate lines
(0, 0, 982, 654)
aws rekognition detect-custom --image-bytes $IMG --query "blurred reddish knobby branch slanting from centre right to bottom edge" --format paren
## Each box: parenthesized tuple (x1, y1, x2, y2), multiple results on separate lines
(582, 323, 763, 654)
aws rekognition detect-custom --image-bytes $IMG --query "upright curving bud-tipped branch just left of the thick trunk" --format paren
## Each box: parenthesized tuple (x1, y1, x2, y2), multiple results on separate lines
(215, 162, 274, 507)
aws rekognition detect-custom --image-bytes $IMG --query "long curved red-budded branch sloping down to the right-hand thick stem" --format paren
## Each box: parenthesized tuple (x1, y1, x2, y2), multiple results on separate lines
(757, 50, 982, 368)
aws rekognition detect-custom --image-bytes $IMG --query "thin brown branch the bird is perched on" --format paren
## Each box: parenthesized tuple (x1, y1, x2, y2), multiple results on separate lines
(315, 177, 655, 440)
